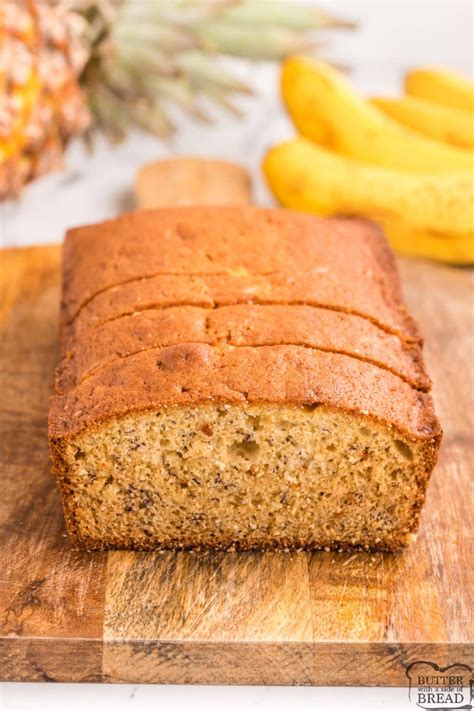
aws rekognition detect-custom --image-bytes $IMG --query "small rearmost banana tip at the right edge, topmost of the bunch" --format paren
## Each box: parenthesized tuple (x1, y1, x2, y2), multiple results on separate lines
(405, 68, 474, 111)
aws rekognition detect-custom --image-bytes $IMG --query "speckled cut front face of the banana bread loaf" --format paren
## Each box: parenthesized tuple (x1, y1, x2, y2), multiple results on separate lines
(53, 404, 437, 550)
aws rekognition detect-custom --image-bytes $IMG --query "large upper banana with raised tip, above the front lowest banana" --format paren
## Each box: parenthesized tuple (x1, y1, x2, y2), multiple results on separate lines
(281, 57, 474, 173)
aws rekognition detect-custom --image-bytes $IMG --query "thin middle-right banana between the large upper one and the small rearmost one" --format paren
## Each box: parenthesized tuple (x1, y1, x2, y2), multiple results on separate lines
(370, 96, 474, 150)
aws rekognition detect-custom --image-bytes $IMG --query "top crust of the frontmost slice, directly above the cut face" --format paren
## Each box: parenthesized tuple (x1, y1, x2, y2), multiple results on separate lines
(50, 343, 439, 439)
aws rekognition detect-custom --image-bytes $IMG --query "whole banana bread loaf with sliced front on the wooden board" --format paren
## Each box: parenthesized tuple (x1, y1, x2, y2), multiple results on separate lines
(49, 207, 441, 550)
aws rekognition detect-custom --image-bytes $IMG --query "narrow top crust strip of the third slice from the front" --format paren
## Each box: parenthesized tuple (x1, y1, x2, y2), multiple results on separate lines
(61, 272, 419, 350)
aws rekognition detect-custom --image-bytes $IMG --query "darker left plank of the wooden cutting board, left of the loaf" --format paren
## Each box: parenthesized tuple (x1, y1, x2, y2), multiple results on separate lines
(0, 248, 106, 681)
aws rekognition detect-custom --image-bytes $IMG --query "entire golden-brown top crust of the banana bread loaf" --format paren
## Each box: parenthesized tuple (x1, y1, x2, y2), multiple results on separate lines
(50, 207, 440, 439)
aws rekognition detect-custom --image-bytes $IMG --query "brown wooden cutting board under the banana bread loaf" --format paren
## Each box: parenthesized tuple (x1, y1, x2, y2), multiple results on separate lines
(0, 247, 474, 685)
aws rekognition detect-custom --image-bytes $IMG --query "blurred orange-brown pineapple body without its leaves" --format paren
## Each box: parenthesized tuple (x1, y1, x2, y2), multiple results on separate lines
(0, 0, 91, 199)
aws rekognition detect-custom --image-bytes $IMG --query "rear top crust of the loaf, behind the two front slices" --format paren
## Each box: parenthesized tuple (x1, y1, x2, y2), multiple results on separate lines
(63, 206, 419, 340)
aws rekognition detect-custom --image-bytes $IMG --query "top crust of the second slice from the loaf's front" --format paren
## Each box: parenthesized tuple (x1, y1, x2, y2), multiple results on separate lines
(56, 304, 430, 392)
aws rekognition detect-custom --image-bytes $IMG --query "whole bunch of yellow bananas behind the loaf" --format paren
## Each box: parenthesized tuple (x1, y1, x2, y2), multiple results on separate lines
(264, 57, 474, 264)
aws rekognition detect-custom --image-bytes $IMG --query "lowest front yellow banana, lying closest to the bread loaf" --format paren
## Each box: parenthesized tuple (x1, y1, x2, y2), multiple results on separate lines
(263, 138, 474, 263)
